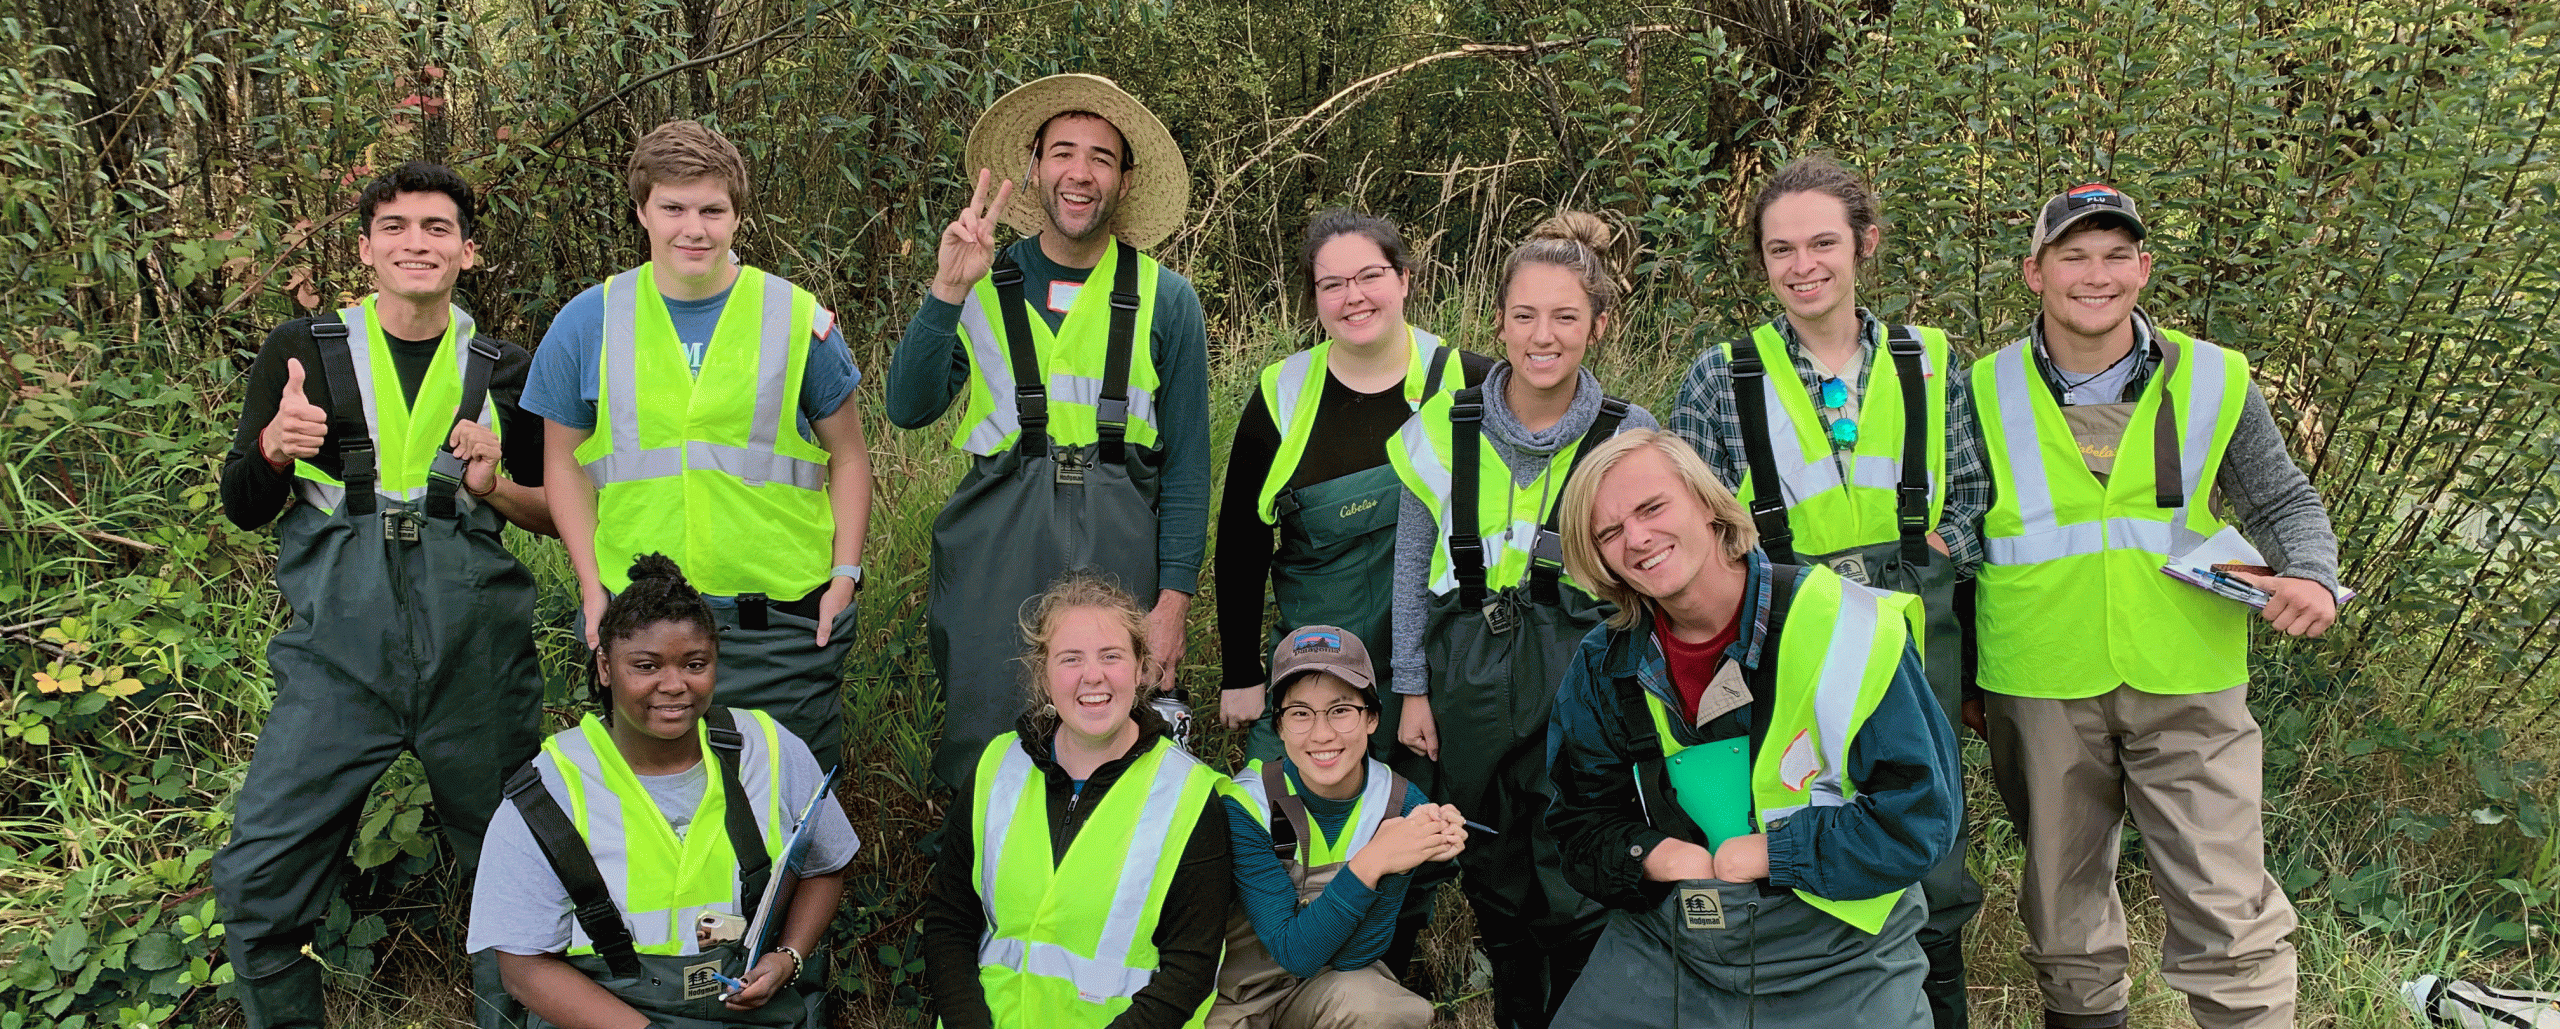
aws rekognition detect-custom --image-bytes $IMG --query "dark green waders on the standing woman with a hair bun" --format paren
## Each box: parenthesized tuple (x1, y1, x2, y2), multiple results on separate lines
(1423, 389, 1628, 1026)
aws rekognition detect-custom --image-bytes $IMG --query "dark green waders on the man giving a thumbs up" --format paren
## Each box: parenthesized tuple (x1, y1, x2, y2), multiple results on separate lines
(210, 320, 543, 1026)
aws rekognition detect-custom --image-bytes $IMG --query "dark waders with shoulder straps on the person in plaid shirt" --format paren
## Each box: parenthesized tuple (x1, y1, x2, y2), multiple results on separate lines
(1733, 325, 1981, 1029)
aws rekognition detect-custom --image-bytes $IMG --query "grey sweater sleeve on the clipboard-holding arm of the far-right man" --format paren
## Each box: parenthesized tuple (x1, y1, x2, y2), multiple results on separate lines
(2214, 381, 2337, 594)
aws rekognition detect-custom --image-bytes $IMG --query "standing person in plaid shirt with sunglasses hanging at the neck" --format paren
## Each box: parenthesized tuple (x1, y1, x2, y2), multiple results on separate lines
(1672, 156, 1992, 1029)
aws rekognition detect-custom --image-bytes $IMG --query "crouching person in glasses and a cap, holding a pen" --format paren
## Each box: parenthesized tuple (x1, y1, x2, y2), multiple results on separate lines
(1208, 625, 1467, 1029)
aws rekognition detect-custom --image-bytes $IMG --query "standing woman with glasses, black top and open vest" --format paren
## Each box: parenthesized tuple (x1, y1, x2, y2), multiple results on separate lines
(1216, 210, 1492, 757)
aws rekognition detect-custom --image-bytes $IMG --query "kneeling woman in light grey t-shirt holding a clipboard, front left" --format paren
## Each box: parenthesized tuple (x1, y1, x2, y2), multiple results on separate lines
(468, 553, 860, 1029)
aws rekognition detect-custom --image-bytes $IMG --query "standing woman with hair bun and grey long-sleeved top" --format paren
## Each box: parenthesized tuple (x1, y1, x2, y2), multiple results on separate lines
(1390, 210, 1654, 1029)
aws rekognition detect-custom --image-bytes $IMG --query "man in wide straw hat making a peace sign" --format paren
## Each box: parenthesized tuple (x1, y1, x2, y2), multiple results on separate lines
(888, 74, 1208, 783)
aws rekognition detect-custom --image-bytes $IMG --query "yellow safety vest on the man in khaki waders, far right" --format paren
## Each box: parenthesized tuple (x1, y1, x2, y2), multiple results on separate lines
(1971, 330, 2248, 699)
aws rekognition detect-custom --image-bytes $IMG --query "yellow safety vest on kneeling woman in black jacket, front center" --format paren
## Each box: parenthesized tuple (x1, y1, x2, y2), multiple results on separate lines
(970, 732, 1226, 1029)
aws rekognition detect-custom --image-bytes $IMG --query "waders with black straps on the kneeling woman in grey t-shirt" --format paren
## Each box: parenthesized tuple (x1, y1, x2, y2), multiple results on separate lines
(507, 706, 819, 1029)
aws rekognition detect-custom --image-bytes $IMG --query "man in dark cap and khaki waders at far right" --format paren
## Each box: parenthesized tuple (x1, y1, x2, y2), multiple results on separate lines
(1966, 184, 2337, 1029)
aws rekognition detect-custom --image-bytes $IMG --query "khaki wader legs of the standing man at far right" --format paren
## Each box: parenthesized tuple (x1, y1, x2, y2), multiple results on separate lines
(1987, 686, 2294, 1029)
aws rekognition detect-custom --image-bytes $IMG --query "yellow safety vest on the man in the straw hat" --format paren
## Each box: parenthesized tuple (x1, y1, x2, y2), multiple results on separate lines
(952, 246, 1162, 458)
